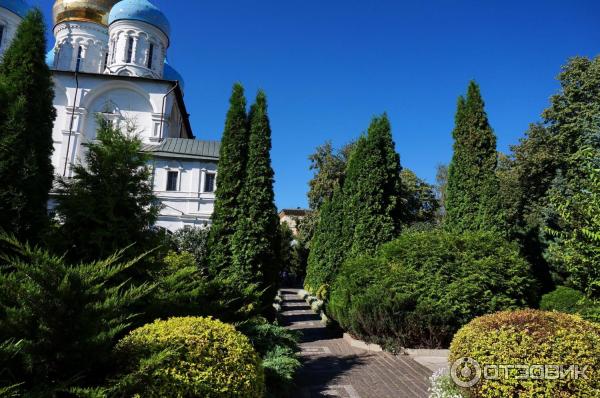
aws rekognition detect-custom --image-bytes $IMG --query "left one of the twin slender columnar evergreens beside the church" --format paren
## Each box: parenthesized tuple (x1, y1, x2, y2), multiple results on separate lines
(206, 83, 248, 276)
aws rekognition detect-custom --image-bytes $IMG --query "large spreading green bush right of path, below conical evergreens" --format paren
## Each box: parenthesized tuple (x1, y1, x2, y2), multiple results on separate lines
(326, 230, 536, 349)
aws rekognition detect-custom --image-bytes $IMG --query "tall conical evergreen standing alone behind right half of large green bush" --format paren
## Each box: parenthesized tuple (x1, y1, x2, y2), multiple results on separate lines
(445, 81, 503, 231)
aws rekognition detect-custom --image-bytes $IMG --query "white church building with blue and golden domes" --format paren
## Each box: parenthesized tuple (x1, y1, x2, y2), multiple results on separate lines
(0, 0, 220, 231)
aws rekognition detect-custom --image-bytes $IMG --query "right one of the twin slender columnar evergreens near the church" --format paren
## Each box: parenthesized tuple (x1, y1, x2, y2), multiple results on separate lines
(232, 91, 279, 299)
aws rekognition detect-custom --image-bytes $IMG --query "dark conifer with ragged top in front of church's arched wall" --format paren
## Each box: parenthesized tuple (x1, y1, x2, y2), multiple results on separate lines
(56, 117, 159, 261)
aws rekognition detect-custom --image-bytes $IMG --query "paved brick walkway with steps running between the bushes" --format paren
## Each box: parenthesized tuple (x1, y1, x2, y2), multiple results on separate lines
(281, 289, 432, 398)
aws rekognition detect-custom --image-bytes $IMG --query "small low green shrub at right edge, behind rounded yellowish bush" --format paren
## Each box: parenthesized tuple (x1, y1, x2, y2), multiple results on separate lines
(540, 286, 600, 322)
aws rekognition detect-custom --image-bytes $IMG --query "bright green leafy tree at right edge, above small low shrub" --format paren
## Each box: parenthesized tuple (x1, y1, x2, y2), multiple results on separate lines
(548, 147, 600, 298)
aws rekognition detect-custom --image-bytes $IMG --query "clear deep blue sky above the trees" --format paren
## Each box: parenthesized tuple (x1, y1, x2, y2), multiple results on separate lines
(30, 0, 600, 208)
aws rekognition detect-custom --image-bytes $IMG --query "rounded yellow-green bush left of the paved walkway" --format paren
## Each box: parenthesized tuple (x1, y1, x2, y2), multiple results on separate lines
(116, 317, 265, 398)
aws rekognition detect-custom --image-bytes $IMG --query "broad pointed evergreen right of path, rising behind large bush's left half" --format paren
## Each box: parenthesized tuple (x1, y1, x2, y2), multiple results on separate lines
(343, 115, 402, 255)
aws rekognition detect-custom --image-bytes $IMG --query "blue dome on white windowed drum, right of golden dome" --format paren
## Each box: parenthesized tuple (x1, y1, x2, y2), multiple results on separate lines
(106, 0, 171, 37)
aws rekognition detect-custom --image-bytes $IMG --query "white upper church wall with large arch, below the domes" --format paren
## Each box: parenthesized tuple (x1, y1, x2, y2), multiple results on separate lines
(53, 72, 186, 176)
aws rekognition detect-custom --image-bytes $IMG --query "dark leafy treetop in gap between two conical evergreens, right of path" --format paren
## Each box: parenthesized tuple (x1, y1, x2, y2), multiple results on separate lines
(400, 168, 440, 225)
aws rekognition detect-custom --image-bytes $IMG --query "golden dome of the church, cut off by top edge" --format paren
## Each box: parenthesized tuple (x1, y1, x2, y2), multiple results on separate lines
(52, 0, 119, 26)
